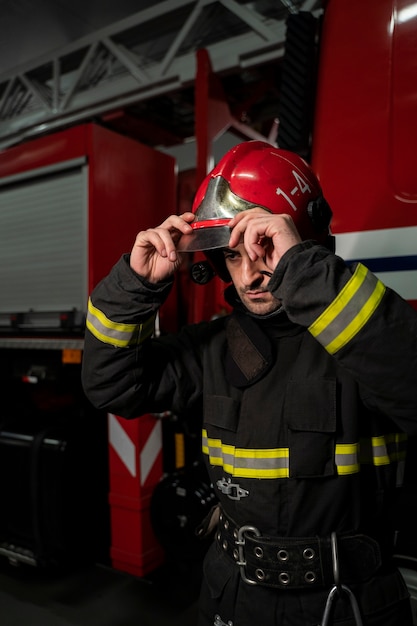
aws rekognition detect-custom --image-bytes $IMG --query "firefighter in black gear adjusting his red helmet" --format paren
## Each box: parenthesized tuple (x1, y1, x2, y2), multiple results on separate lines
(83, 141, 417, 626)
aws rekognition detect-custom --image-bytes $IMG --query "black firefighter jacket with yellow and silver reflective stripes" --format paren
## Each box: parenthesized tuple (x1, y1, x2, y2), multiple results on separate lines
(83, 242, 417, 540)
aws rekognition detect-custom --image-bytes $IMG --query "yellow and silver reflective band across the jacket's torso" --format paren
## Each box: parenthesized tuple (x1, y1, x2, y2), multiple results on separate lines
(203, 429, 407, 479)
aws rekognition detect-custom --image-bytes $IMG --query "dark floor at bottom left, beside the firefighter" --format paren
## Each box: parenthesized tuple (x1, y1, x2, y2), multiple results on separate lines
(0, 561, 200, 626)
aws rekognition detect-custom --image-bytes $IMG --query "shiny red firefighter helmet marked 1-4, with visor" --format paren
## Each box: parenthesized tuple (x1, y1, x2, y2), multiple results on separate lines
(179, 141, 332, 252)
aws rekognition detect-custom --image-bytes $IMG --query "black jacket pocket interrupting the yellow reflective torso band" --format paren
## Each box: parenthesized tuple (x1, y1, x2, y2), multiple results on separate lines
(285, 379, 336, 478)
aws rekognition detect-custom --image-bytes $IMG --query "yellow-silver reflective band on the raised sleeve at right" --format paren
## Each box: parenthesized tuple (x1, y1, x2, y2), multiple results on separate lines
(309, 263, 385, 354)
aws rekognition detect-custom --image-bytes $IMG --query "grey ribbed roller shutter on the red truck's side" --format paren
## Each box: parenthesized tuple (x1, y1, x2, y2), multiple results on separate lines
(0, 159, 88, 314)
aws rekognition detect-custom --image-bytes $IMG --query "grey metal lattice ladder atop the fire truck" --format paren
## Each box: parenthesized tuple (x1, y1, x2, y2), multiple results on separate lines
(0, 0, 322, 149)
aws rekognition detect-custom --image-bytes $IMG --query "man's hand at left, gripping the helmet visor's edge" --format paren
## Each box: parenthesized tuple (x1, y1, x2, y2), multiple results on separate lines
(130, 212, 195, 283)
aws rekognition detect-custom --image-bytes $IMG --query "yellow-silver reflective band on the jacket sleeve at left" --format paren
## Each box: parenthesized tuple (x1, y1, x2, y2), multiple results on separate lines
(86, 299, 156, 348)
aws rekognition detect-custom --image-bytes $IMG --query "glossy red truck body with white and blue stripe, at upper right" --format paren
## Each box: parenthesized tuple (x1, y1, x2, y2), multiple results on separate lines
(312, 0, 417, 306)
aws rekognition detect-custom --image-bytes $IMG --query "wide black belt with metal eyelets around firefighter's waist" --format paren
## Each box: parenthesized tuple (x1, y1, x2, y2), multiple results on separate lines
(216, 512, 381, 589)
